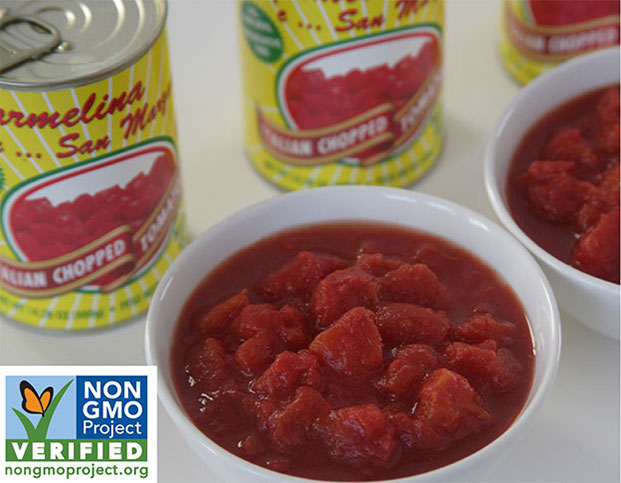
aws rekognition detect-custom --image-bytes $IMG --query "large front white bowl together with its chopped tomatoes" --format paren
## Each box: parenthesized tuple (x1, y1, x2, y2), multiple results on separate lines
(145, 186, 560, 482)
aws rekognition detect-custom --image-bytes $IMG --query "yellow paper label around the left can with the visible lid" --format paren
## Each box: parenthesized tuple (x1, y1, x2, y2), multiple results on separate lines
(0, 32, 187, 330)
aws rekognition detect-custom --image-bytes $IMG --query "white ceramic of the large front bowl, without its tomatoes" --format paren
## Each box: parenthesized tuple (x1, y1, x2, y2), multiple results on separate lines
(145, 186, 561, 482)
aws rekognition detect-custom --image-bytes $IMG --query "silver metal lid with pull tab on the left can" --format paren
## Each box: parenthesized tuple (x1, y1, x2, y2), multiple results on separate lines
(0, 0, 166, 91)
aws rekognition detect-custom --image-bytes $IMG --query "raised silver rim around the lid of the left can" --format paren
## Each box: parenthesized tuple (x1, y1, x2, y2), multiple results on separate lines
(0, 0, 168, 92)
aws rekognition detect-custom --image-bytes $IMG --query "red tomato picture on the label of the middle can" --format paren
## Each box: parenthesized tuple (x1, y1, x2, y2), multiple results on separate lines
(277, 27, 441, 168)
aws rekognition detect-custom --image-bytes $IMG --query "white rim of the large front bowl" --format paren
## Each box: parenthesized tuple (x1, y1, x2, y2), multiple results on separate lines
(144, 186, 561, 483)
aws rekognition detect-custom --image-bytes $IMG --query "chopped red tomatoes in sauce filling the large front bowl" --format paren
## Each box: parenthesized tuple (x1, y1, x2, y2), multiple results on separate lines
(171, 223, 534, 481)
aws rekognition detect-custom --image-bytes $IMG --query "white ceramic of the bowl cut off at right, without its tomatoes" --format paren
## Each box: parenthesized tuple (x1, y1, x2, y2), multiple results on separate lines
(485, 47, 620, 339)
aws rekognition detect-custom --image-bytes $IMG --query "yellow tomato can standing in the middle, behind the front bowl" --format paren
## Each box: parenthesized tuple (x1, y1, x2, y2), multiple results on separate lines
(237, 0, 444, 190)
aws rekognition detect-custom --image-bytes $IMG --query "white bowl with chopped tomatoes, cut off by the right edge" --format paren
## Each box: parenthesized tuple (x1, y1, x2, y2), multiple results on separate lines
(485, 47, 620, 339)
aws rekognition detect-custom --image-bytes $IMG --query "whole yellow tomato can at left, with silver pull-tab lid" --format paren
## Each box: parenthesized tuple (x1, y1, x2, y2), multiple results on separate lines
(0, 0, 187, 330)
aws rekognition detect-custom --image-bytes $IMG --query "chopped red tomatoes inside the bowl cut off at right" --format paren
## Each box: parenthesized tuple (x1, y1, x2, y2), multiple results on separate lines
(506, 85, 619, 283)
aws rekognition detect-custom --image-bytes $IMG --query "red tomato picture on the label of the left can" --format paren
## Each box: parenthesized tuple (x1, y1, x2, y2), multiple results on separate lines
(3, 141, 179, 291)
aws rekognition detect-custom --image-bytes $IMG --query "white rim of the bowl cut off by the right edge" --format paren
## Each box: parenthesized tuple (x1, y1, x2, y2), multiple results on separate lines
(483, 46, 620, 297)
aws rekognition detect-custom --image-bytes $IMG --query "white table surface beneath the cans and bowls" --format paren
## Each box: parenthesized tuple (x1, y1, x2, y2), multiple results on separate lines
(0, 0, 620, 483)
